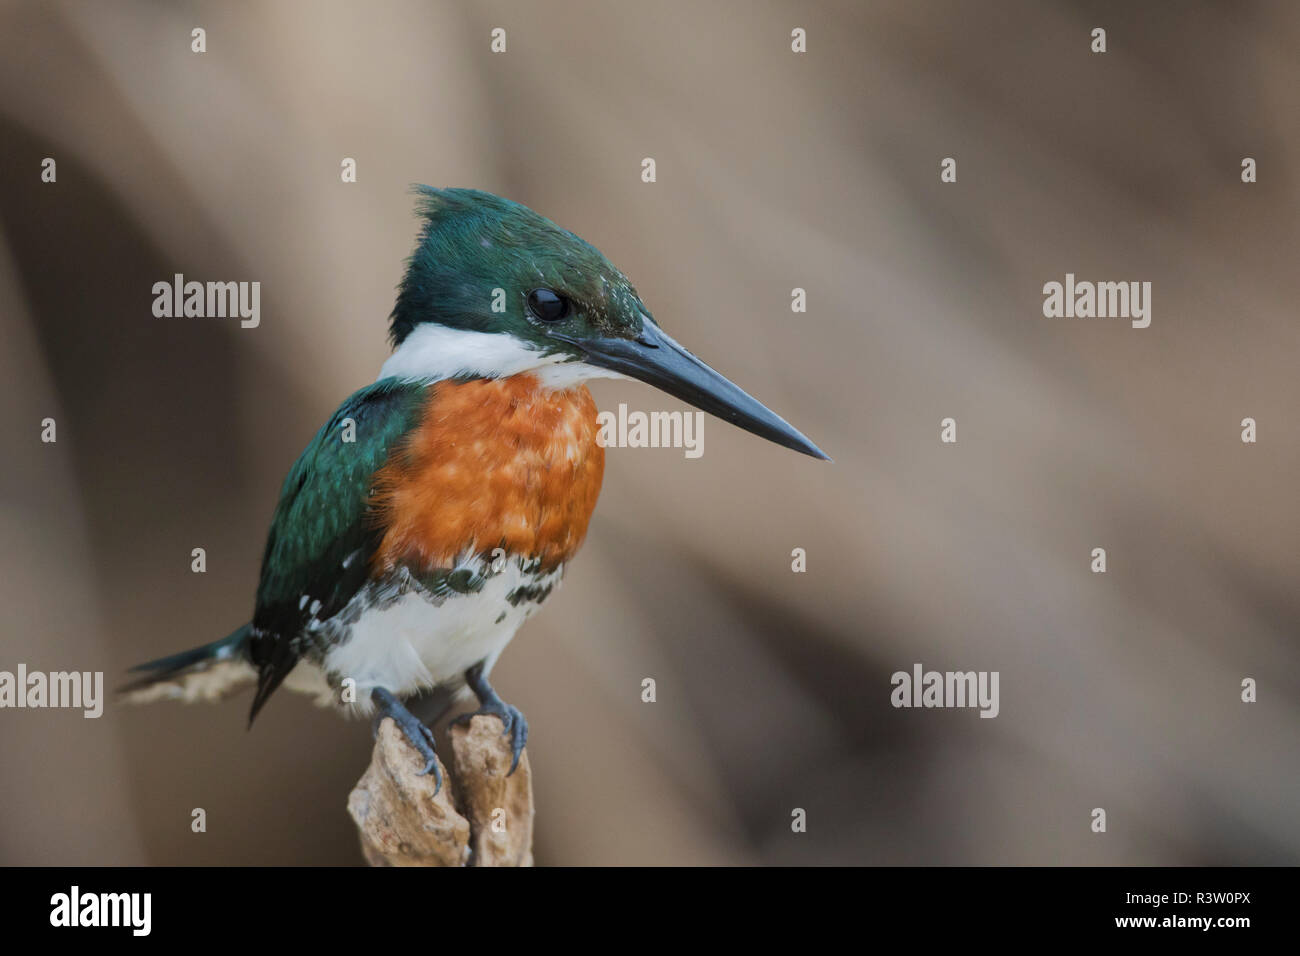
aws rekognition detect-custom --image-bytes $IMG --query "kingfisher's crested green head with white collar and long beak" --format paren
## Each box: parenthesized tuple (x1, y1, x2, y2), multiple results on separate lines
(381, 186, 826, 459)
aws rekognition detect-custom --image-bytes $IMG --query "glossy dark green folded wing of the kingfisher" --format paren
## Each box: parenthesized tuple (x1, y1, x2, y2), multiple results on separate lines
(248, 378, 426, 721)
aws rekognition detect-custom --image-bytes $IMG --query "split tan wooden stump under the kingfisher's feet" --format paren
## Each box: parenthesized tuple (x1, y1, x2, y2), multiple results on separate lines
(347, 717, 533, 866)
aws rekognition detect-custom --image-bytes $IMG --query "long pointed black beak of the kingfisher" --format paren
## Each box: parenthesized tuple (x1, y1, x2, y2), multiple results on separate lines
(553, 317, 831, 462)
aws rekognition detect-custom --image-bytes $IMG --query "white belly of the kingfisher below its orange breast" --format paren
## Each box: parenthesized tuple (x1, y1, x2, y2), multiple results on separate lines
(285, 562, 563, 713)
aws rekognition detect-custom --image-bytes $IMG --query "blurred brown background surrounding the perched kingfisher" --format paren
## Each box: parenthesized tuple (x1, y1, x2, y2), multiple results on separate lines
(0, 0, 1300, 864)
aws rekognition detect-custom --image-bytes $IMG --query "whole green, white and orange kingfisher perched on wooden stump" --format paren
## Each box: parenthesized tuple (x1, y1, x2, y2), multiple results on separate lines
(122, 186, 827, 788)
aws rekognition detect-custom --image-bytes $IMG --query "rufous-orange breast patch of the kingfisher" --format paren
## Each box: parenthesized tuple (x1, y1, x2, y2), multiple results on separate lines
(373, 375, 605, 571)
